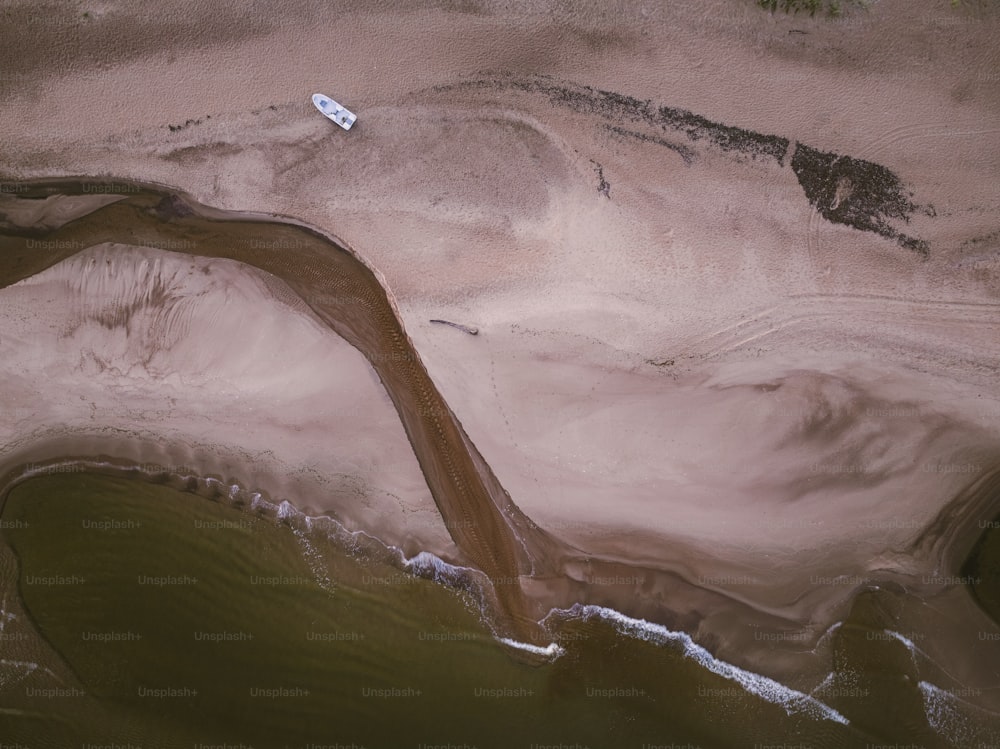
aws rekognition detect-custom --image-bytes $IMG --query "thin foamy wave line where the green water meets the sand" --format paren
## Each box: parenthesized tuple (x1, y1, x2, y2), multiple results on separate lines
(0, 450, 1000, 727)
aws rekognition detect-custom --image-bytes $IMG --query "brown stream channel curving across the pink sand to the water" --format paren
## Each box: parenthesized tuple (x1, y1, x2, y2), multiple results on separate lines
(0, 182, 554, 641)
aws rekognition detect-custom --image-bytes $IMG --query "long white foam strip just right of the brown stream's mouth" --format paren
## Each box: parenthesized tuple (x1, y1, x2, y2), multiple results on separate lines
(546, 603, 850, 726)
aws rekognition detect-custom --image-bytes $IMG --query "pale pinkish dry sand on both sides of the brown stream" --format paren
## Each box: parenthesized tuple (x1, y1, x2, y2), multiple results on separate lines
(0, 0, 1000, 707)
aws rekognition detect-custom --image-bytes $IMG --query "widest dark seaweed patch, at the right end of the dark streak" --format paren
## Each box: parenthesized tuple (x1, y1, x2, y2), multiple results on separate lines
(792, 143, 928, 255)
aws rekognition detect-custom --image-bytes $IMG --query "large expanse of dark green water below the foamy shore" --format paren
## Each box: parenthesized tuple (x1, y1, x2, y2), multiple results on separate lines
(0, 474, 900, 749)
